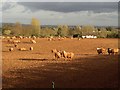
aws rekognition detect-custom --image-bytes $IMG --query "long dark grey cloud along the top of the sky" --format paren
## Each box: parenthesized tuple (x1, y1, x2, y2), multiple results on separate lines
(18, 2, 118, 13)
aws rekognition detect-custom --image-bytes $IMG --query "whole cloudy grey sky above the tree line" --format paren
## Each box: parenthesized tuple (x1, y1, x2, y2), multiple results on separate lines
(0, 0, 118, 26)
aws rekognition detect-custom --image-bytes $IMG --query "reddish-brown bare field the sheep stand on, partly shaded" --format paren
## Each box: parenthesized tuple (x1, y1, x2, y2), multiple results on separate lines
(2, 38, 118, 88)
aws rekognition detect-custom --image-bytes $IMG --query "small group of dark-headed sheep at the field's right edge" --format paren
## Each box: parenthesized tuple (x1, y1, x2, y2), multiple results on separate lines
(97, 47, 119, 55)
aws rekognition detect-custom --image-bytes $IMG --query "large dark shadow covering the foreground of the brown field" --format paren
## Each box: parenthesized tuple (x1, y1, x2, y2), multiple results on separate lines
(3, 55, 118, 88)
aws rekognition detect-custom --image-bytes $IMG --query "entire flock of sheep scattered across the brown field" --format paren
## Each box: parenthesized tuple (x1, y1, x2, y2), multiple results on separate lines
(3, 36, 119, 60)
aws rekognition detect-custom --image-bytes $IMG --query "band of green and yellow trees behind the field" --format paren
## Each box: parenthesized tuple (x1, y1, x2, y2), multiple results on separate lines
(0, 18, 120, 38)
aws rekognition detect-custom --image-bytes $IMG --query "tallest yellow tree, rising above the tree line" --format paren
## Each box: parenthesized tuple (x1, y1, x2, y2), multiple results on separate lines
(31, 18, 40, 36)
